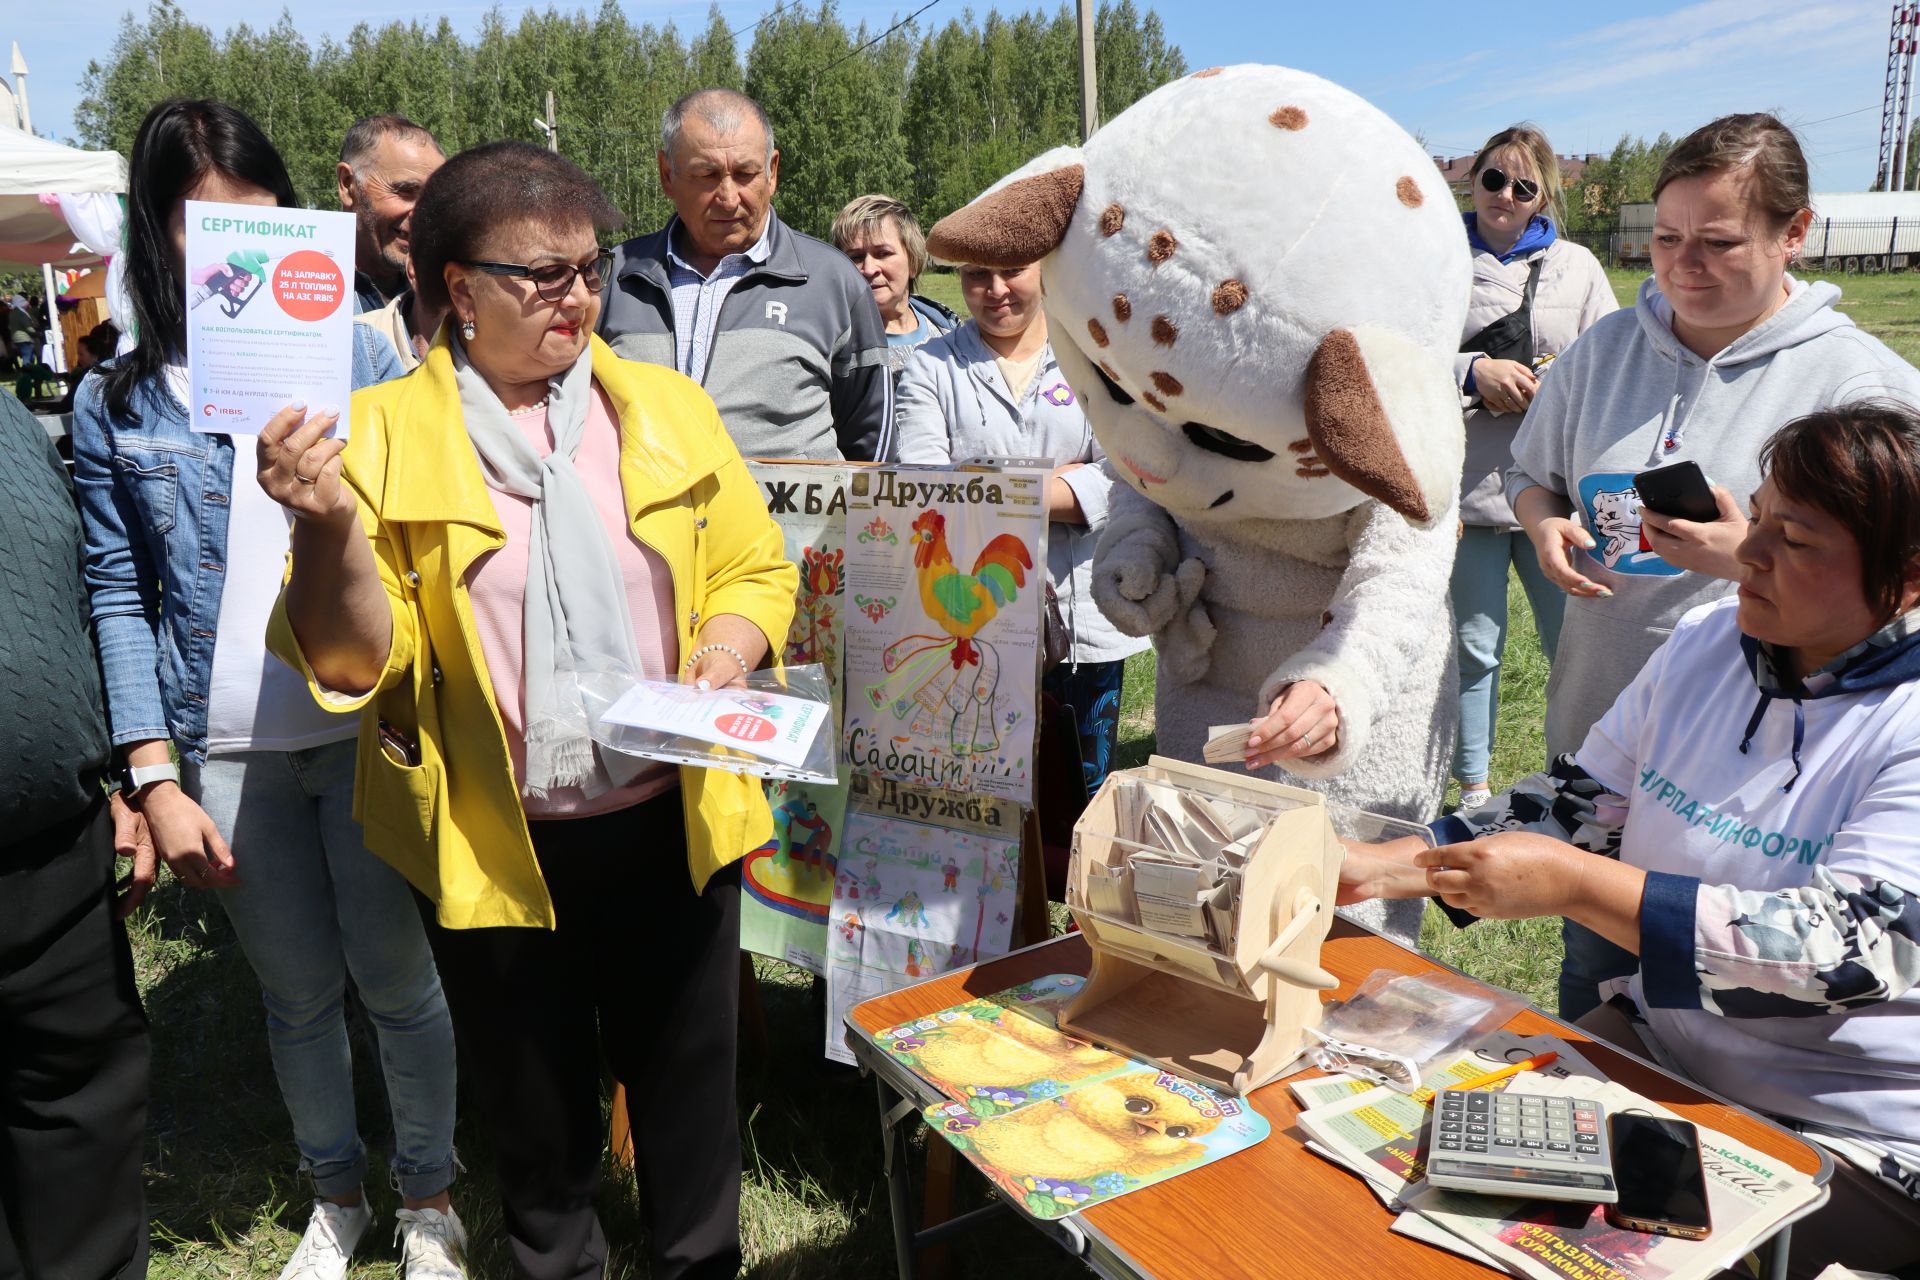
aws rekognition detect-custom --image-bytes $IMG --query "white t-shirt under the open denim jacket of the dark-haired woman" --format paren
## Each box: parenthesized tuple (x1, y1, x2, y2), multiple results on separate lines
(167, 365, 359, 756)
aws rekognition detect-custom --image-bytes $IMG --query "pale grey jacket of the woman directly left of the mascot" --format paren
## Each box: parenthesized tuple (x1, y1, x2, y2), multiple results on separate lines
(895, 320, 1152, 662)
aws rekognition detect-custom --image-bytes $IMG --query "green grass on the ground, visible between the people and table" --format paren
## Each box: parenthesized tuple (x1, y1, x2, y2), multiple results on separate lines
(132, 271, 1920, 1280)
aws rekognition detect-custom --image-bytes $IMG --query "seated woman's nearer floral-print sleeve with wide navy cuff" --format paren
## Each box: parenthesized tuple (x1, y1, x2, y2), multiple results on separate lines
(1640, 867, 1920, 1017)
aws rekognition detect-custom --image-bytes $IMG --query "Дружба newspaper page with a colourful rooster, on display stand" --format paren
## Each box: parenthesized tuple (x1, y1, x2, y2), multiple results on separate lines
(841, 466, 1048, 804)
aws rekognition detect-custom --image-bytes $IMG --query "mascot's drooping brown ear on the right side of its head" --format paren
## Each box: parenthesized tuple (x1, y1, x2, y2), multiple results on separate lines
(1306, 328, 1432, 524)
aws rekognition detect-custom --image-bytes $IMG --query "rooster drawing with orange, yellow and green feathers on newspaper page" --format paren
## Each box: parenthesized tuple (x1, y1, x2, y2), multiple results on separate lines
(868, 510, 1033, 754)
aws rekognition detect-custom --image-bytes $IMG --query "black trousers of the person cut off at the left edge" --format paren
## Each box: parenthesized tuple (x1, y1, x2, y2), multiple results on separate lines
(0, 798, 148, 1280)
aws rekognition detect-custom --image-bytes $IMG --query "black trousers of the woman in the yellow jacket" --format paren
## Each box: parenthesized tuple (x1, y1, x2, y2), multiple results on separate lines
(428, 791, 741, 1280)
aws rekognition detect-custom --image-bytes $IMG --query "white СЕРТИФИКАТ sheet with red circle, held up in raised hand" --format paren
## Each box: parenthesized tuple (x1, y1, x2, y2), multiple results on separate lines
(186, 200, 353, 436)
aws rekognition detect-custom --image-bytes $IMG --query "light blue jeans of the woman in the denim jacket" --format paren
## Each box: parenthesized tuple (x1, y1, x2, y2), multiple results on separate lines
(182, 739, 453, 1199)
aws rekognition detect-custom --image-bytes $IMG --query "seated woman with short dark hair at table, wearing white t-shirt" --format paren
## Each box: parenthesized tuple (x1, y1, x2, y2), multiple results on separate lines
(1340, 403, 1920, 1276)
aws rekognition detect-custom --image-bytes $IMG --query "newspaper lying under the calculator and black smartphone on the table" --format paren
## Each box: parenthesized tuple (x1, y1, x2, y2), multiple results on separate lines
(1394, 1075, 1824, 1280)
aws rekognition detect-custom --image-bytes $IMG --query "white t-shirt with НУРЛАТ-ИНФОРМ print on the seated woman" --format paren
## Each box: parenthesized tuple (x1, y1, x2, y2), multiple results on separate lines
(1578, 599, 1920, 1155)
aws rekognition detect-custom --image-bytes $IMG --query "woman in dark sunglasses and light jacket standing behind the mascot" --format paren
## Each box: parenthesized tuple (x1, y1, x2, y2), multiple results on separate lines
(1452, 125, 1619, 810)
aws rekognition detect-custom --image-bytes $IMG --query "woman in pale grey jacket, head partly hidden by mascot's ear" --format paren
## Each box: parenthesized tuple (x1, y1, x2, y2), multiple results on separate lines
(893, 267, 1150, 793)
